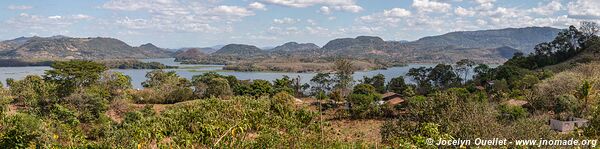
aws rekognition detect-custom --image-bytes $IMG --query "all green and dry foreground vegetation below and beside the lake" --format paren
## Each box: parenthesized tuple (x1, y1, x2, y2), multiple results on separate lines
(0, 21, 600, 148)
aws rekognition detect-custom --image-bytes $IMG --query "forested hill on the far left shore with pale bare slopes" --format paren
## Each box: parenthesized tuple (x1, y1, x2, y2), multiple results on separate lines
(0, 36, 172, 59)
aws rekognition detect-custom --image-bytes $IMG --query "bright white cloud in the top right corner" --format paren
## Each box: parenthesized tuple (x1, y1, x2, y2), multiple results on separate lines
(567, 0, 600, 19)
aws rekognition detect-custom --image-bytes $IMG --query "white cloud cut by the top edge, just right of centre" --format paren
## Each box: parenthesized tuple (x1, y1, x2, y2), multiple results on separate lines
(264, 0, 363, 14)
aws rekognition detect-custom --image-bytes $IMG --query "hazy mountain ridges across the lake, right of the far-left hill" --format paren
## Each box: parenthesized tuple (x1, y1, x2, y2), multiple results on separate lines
(176, 27, 561, 63)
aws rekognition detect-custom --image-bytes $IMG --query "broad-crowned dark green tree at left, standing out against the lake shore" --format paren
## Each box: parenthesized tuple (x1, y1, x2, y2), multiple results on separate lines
(44, 60, 108, 97)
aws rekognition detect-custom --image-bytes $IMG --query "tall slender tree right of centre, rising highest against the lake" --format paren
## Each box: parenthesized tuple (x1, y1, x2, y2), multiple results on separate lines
(334, 59, 356, 96)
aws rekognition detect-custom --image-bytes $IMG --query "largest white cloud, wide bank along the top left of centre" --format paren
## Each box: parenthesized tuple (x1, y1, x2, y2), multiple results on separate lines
(102, 0, 254, 33)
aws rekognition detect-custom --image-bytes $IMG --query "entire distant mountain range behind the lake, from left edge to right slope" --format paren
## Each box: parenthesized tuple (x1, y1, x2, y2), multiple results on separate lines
(0, 27, 560, 63)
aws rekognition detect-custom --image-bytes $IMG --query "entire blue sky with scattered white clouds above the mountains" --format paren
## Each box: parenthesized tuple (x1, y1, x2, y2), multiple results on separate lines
(0, 0, 600, 48)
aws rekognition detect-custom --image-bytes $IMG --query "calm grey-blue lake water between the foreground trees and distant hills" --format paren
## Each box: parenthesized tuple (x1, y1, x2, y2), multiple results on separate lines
(0, 58, 482, 88)
